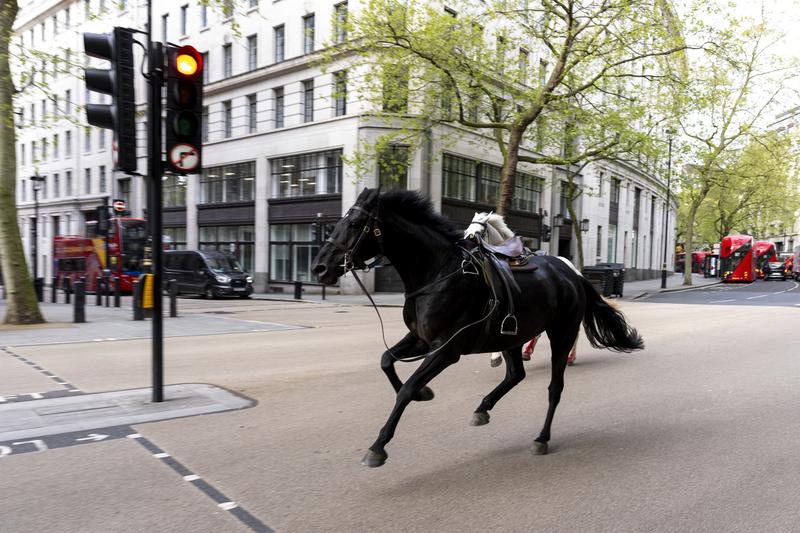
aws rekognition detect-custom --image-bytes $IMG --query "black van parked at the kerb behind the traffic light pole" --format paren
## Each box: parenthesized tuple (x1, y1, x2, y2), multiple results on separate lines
(163, 250, 253, 299)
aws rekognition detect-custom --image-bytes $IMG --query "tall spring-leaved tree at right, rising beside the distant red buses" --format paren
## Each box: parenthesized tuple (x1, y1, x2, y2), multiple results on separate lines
(676, 17, 795, 285)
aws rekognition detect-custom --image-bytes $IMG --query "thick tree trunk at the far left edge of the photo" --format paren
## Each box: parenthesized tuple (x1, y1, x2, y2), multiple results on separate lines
(0, 0, 44, 324)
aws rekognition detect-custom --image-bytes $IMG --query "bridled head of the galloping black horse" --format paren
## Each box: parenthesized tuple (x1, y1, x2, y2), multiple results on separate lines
(311, 189, 380, 285)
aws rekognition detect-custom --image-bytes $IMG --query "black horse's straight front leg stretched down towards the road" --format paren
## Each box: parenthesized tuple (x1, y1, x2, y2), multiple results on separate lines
(361, 353, 459, 467)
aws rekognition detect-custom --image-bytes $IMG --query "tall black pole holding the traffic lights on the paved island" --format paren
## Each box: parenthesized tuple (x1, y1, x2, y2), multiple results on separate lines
(147, 41, 164, 402)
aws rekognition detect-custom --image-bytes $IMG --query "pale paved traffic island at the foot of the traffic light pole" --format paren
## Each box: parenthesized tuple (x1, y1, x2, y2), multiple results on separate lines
(0, 383, 255, 443)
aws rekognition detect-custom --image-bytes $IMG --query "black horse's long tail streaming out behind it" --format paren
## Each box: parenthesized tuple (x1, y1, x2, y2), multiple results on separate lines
(581, 276, 644, 352)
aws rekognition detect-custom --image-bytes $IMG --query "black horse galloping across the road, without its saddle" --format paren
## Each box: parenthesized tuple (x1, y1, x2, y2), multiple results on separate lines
(312, 189, 644, 467)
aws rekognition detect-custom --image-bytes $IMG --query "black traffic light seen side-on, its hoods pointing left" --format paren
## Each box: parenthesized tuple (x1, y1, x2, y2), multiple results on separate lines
(83, 28, 136, 172)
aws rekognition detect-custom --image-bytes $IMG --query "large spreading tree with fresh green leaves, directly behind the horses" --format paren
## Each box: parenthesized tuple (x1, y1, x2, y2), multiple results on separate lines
(325, 0, 686, 227)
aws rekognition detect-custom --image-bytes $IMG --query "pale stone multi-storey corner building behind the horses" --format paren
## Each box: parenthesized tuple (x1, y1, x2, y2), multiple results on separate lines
(15, 0, 675, 292)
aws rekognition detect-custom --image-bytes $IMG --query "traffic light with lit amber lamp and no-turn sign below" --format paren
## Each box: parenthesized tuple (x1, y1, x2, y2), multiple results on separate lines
(165, 45, 204, 174)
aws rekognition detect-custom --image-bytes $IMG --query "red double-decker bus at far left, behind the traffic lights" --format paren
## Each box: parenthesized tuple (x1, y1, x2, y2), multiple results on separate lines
(53, 218, 147, 292)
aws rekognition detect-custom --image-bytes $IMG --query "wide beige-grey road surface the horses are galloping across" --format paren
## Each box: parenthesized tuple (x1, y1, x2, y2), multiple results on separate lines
(0, 282, 800, 532)
